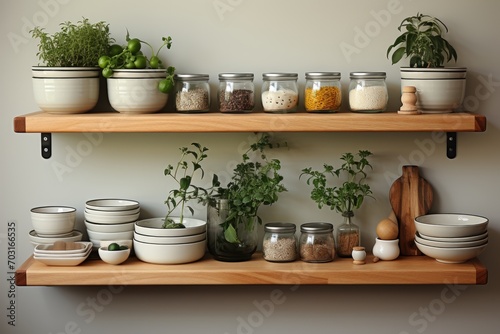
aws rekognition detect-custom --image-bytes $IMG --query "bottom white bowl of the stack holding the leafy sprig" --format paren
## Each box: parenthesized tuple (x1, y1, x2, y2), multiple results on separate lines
(134, 240, 207, 264)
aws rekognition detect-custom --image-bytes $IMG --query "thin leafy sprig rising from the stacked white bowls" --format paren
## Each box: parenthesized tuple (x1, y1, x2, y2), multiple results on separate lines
(163, 143, 209, 228)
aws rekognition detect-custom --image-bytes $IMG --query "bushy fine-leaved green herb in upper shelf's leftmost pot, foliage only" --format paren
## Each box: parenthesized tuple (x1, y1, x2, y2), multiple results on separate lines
(30, 18, 114, 67)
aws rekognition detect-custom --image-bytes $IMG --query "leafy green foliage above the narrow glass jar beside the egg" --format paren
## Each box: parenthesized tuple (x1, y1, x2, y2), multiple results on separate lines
(299, 151, 372, 214)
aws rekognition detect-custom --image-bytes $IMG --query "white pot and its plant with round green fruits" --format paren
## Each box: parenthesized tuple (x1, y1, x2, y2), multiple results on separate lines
(99, 31, 175, 114)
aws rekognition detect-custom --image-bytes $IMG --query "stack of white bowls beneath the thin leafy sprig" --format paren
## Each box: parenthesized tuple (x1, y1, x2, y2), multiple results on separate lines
(134, 218, 207, 264)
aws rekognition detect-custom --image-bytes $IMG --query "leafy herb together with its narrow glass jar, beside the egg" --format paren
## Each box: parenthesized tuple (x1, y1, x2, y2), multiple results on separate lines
(299, 151, 372, 257)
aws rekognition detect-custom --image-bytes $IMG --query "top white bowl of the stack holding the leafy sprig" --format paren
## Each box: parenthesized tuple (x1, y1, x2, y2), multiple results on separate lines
(135, 218, 207, 237)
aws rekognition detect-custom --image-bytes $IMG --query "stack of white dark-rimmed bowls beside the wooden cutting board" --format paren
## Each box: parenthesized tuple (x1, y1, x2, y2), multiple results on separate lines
(415, 213, 488, 263)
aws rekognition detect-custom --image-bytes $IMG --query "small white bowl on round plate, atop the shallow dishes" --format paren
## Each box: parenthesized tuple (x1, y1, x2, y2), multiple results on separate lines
(29, 206, 82, 246)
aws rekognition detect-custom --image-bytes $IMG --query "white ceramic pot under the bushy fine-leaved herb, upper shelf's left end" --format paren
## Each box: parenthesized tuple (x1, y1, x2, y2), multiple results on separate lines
(32, 66, 100, 114)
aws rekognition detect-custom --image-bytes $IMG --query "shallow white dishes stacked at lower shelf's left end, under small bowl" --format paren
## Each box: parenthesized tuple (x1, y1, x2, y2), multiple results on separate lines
(33, 241, 92, 266)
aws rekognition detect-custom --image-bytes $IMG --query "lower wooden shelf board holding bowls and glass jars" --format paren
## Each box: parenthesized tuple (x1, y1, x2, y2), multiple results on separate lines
(16, 253, 488, 286)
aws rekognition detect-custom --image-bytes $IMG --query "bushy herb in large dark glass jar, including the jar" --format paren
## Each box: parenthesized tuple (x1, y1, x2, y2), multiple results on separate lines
(207, 134, 286, 261)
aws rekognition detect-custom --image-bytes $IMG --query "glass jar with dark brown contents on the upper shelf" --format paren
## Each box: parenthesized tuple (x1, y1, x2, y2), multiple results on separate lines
(218, 73, 254, 112)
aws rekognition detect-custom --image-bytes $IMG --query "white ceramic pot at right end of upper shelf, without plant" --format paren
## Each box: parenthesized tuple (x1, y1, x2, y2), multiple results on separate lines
(401, 67, 467, 113)
